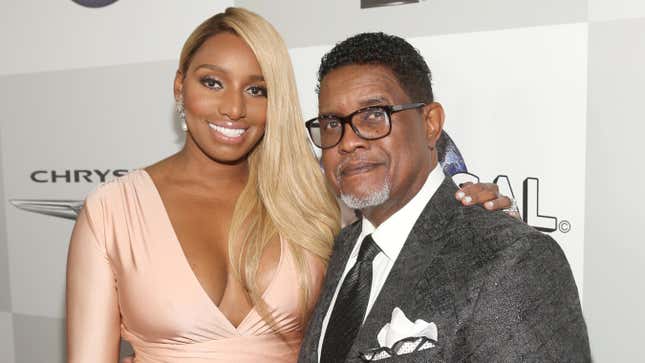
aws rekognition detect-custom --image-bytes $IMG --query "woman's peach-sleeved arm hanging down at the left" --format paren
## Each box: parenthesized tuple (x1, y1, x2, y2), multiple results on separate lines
(67, 202, 120, 363)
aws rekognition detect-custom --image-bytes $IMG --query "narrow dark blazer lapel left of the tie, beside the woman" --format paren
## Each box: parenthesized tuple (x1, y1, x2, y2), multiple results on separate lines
(298, 221, 362, 363)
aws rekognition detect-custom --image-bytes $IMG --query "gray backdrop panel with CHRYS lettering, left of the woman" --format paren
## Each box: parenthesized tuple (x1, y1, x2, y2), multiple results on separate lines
(0, 61, 183, 318)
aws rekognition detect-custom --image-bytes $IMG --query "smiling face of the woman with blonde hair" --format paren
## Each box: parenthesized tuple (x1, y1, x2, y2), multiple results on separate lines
(175, 33, 267, 163)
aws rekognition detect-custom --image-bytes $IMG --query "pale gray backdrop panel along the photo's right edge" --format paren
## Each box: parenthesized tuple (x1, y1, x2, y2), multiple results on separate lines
(584, 19, 645, 362)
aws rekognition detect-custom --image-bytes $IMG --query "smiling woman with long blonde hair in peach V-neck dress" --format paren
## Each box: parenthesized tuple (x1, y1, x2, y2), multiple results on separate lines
(67, 8, 503, 363)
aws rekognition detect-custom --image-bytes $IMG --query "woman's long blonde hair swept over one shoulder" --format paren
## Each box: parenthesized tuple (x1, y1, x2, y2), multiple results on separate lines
(179, 8, 340, 323)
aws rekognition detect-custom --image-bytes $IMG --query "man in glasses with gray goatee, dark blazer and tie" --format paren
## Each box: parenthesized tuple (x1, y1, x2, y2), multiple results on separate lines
(299, 33, 590, 363)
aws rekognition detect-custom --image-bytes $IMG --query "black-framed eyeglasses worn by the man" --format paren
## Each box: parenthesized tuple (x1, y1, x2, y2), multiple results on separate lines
(305, 102, 425, 149)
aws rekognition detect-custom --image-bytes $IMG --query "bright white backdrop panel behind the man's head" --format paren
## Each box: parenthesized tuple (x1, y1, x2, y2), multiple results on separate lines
(291, 24, 587, 300)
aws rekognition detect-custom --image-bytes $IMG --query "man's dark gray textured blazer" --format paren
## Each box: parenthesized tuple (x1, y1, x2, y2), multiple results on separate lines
(298, 178, 591, 363)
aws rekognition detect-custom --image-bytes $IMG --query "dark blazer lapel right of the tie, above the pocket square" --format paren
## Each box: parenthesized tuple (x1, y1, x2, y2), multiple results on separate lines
(348, 177, 458, 359)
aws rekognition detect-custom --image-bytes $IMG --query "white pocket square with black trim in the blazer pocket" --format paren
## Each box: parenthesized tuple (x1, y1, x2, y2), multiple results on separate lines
(361, 307, 438, 361)
